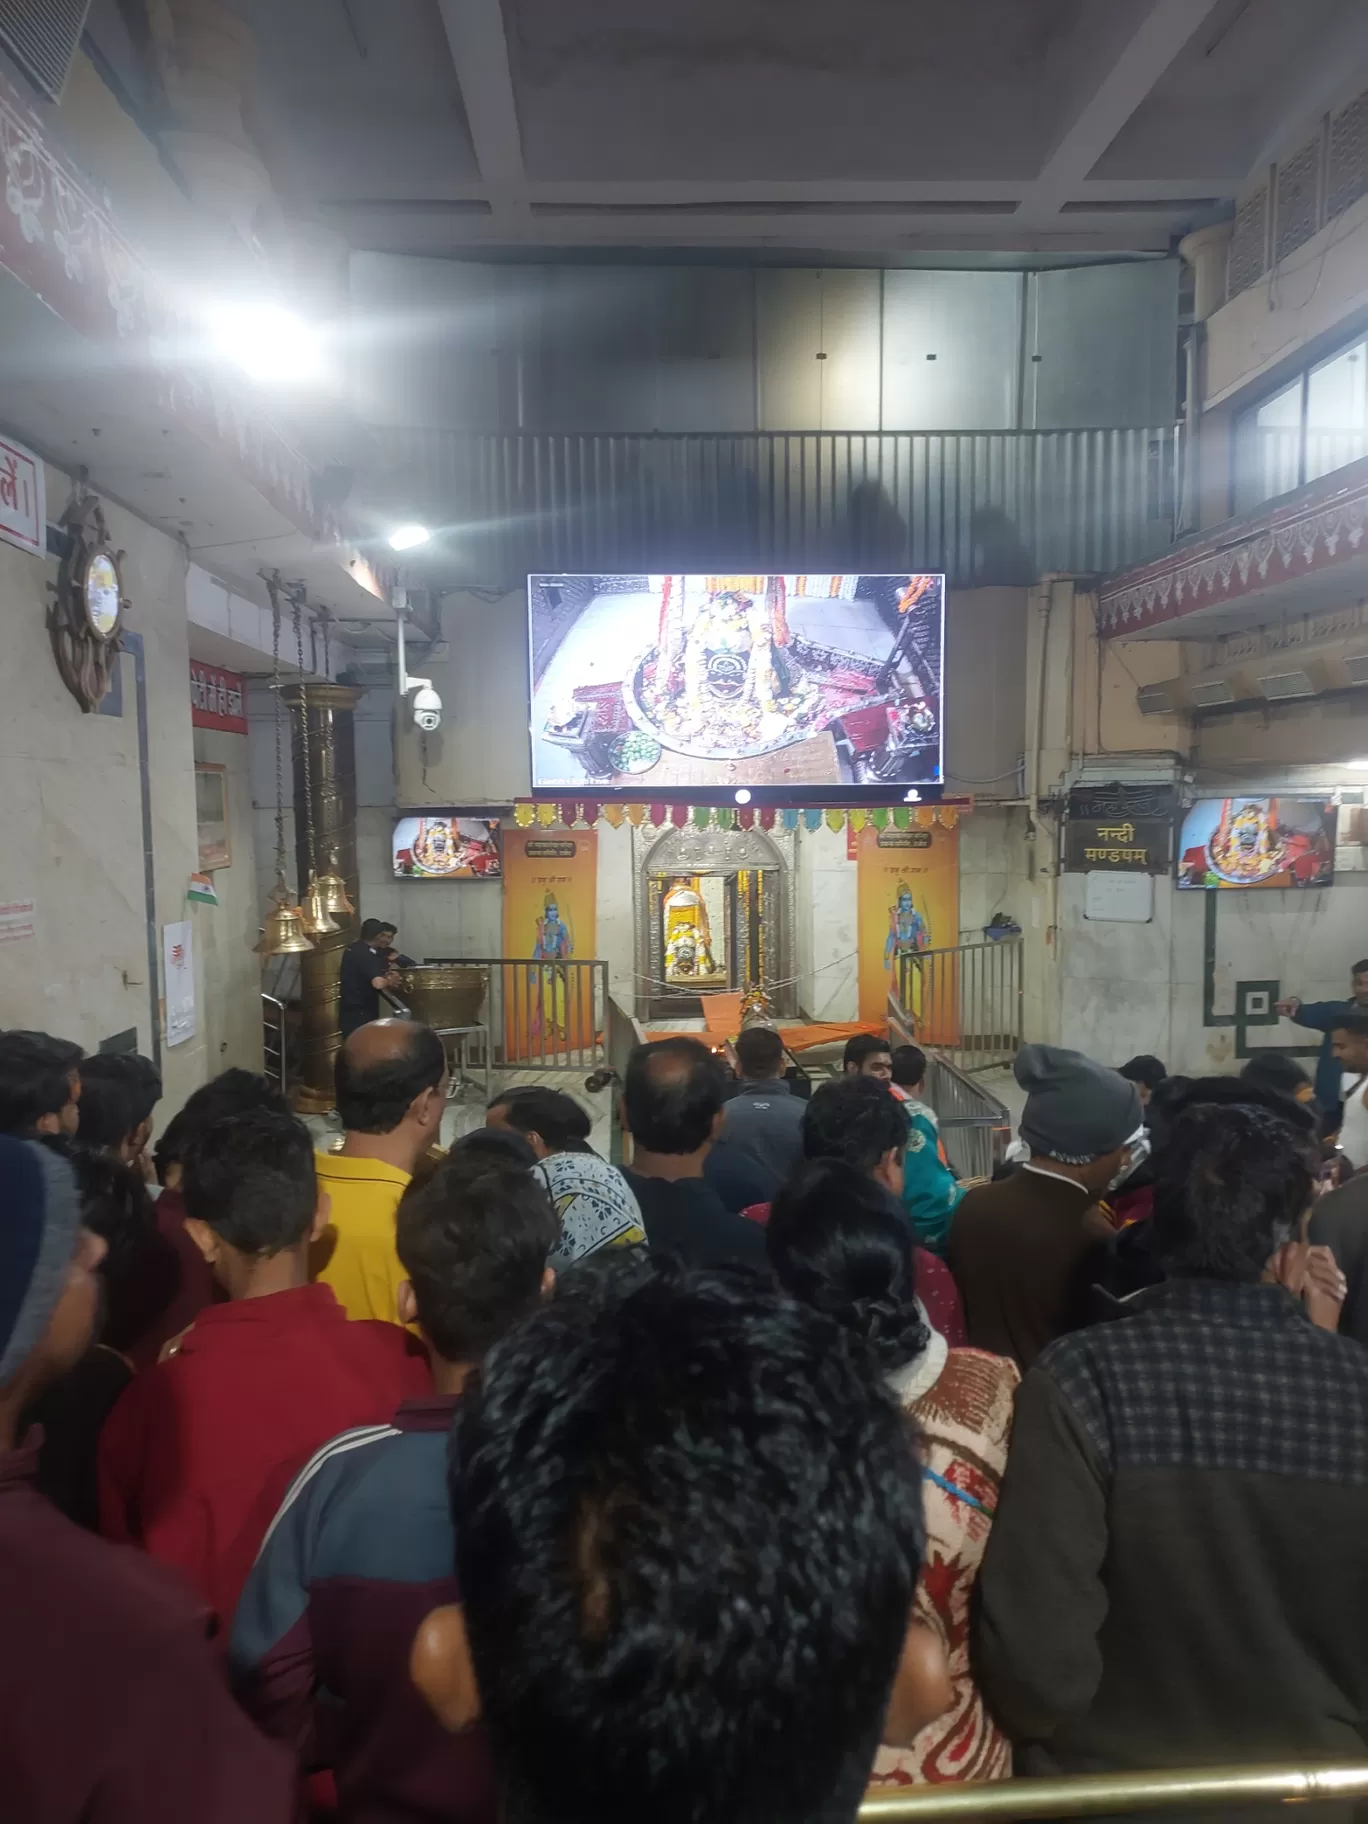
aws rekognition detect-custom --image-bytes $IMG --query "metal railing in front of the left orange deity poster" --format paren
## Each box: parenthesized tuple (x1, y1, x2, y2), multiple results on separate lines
(425, 956, 607, 1071)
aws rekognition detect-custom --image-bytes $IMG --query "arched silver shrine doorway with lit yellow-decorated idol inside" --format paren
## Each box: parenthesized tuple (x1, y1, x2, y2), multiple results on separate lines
(637, 830, 797, 1020)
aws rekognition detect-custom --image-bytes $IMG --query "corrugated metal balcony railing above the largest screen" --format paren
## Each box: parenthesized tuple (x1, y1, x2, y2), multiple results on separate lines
(372, 425, 1182, 589)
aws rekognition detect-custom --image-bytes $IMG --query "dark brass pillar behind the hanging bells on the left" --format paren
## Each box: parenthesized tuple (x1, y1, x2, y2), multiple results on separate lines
(281, 684, 363, 1114)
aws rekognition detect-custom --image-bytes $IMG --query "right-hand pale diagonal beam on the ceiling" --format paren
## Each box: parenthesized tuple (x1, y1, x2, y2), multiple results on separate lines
(1023, 0, 1217, 221)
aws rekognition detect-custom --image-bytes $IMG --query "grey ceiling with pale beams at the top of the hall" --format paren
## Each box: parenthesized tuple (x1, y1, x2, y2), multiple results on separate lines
(219, 0, 1368, 263)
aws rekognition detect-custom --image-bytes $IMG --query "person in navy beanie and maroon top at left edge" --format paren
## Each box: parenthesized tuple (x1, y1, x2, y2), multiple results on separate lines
(0, 1136, 295, 1824)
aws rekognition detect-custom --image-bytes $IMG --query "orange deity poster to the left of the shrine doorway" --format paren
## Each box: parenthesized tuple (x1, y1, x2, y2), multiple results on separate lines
(503, 826, 598, 1062)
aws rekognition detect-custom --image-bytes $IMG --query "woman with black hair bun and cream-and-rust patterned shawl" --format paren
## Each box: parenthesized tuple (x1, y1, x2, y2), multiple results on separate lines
(764, 1158, 1020, 1786)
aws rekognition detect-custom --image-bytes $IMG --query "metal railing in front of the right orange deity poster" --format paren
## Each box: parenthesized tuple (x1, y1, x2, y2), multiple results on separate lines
(897, 938, 1021, 1071)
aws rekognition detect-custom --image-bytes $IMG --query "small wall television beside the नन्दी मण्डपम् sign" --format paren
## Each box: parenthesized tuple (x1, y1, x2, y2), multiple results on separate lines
(1178, 797, 1335, 888)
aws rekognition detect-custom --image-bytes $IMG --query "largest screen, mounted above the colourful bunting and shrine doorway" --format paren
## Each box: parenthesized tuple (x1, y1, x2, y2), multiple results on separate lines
(527, 573, 945, 804)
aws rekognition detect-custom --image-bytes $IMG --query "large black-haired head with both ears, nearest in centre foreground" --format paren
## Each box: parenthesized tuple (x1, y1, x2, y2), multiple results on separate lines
(412, 1251, 950, 1824)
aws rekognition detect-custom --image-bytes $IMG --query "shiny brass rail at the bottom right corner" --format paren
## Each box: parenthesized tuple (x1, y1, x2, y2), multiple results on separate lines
(859, 1764, 1368, 1824)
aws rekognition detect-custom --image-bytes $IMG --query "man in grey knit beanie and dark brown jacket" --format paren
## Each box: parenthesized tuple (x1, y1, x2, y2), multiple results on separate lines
(947, 1045, 1144, 1372)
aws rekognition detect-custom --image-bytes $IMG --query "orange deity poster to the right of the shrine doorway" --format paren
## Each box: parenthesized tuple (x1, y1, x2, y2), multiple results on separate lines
(855, 824, 959, 1045)
